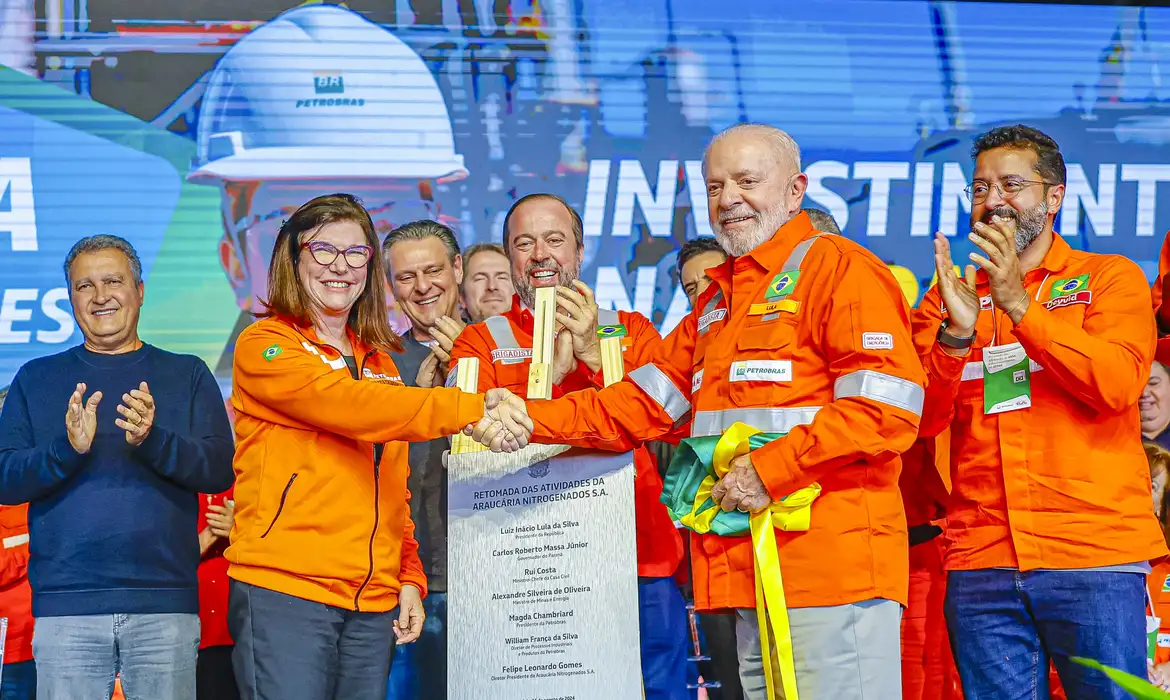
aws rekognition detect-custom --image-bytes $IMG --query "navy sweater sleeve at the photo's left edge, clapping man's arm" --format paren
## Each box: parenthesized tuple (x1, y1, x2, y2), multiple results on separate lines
(0, 372, 87, 506)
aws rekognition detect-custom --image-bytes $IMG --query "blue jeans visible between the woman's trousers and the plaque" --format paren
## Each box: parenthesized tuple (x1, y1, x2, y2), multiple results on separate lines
(386, 593, 447, 700)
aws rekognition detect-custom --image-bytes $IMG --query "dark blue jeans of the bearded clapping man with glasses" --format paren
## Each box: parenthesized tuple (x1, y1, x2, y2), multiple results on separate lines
(945, 569, 1147, 700)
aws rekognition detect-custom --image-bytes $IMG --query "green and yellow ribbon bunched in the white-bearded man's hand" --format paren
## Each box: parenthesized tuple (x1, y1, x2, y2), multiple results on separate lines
(662, 423, 820, 700)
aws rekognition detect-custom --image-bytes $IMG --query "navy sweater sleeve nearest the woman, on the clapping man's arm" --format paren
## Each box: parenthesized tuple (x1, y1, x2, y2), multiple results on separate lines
(135, 359, 235, 494)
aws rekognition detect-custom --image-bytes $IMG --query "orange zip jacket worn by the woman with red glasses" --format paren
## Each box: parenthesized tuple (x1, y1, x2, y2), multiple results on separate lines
(226, 318, 483, 612)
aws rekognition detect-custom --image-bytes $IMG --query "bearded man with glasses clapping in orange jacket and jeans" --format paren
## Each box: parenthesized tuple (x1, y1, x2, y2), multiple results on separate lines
(915, 125, 1166, 700)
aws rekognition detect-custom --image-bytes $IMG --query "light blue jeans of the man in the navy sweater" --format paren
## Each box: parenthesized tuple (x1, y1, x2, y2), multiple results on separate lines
(33, 613, 199, 700)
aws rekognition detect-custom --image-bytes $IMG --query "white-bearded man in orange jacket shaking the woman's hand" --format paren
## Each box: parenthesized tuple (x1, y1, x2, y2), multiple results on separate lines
(476, 124, 924, 700)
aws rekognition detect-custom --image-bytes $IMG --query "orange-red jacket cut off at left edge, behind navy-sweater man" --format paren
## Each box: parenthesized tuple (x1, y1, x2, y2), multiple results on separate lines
(0, 505, 33, 664)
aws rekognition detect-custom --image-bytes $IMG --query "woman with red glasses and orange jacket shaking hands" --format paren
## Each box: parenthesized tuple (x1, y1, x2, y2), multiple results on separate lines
(219, 194, 531, 700)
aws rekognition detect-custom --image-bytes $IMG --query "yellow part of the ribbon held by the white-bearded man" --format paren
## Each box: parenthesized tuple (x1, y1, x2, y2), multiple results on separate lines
(680, 423, 820, 700)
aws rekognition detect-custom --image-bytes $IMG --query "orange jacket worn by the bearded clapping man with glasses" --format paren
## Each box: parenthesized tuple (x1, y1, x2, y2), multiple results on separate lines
(915, 235, 1166, 570)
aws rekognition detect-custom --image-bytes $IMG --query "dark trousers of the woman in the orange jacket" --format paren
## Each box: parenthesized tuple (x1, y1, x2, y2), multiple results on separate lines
(228, 581, 397, 700)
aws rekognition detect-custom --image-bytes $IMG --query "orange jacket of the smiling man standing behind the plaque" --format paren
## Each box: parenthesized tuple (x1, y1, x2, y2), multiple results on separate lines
(448, 296, 683, 578)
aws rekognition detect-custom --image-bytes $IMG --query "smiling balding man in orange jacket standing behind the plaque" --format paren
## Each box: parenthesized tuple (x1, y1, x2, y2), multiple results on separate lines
(448, 194, 690, 700)
